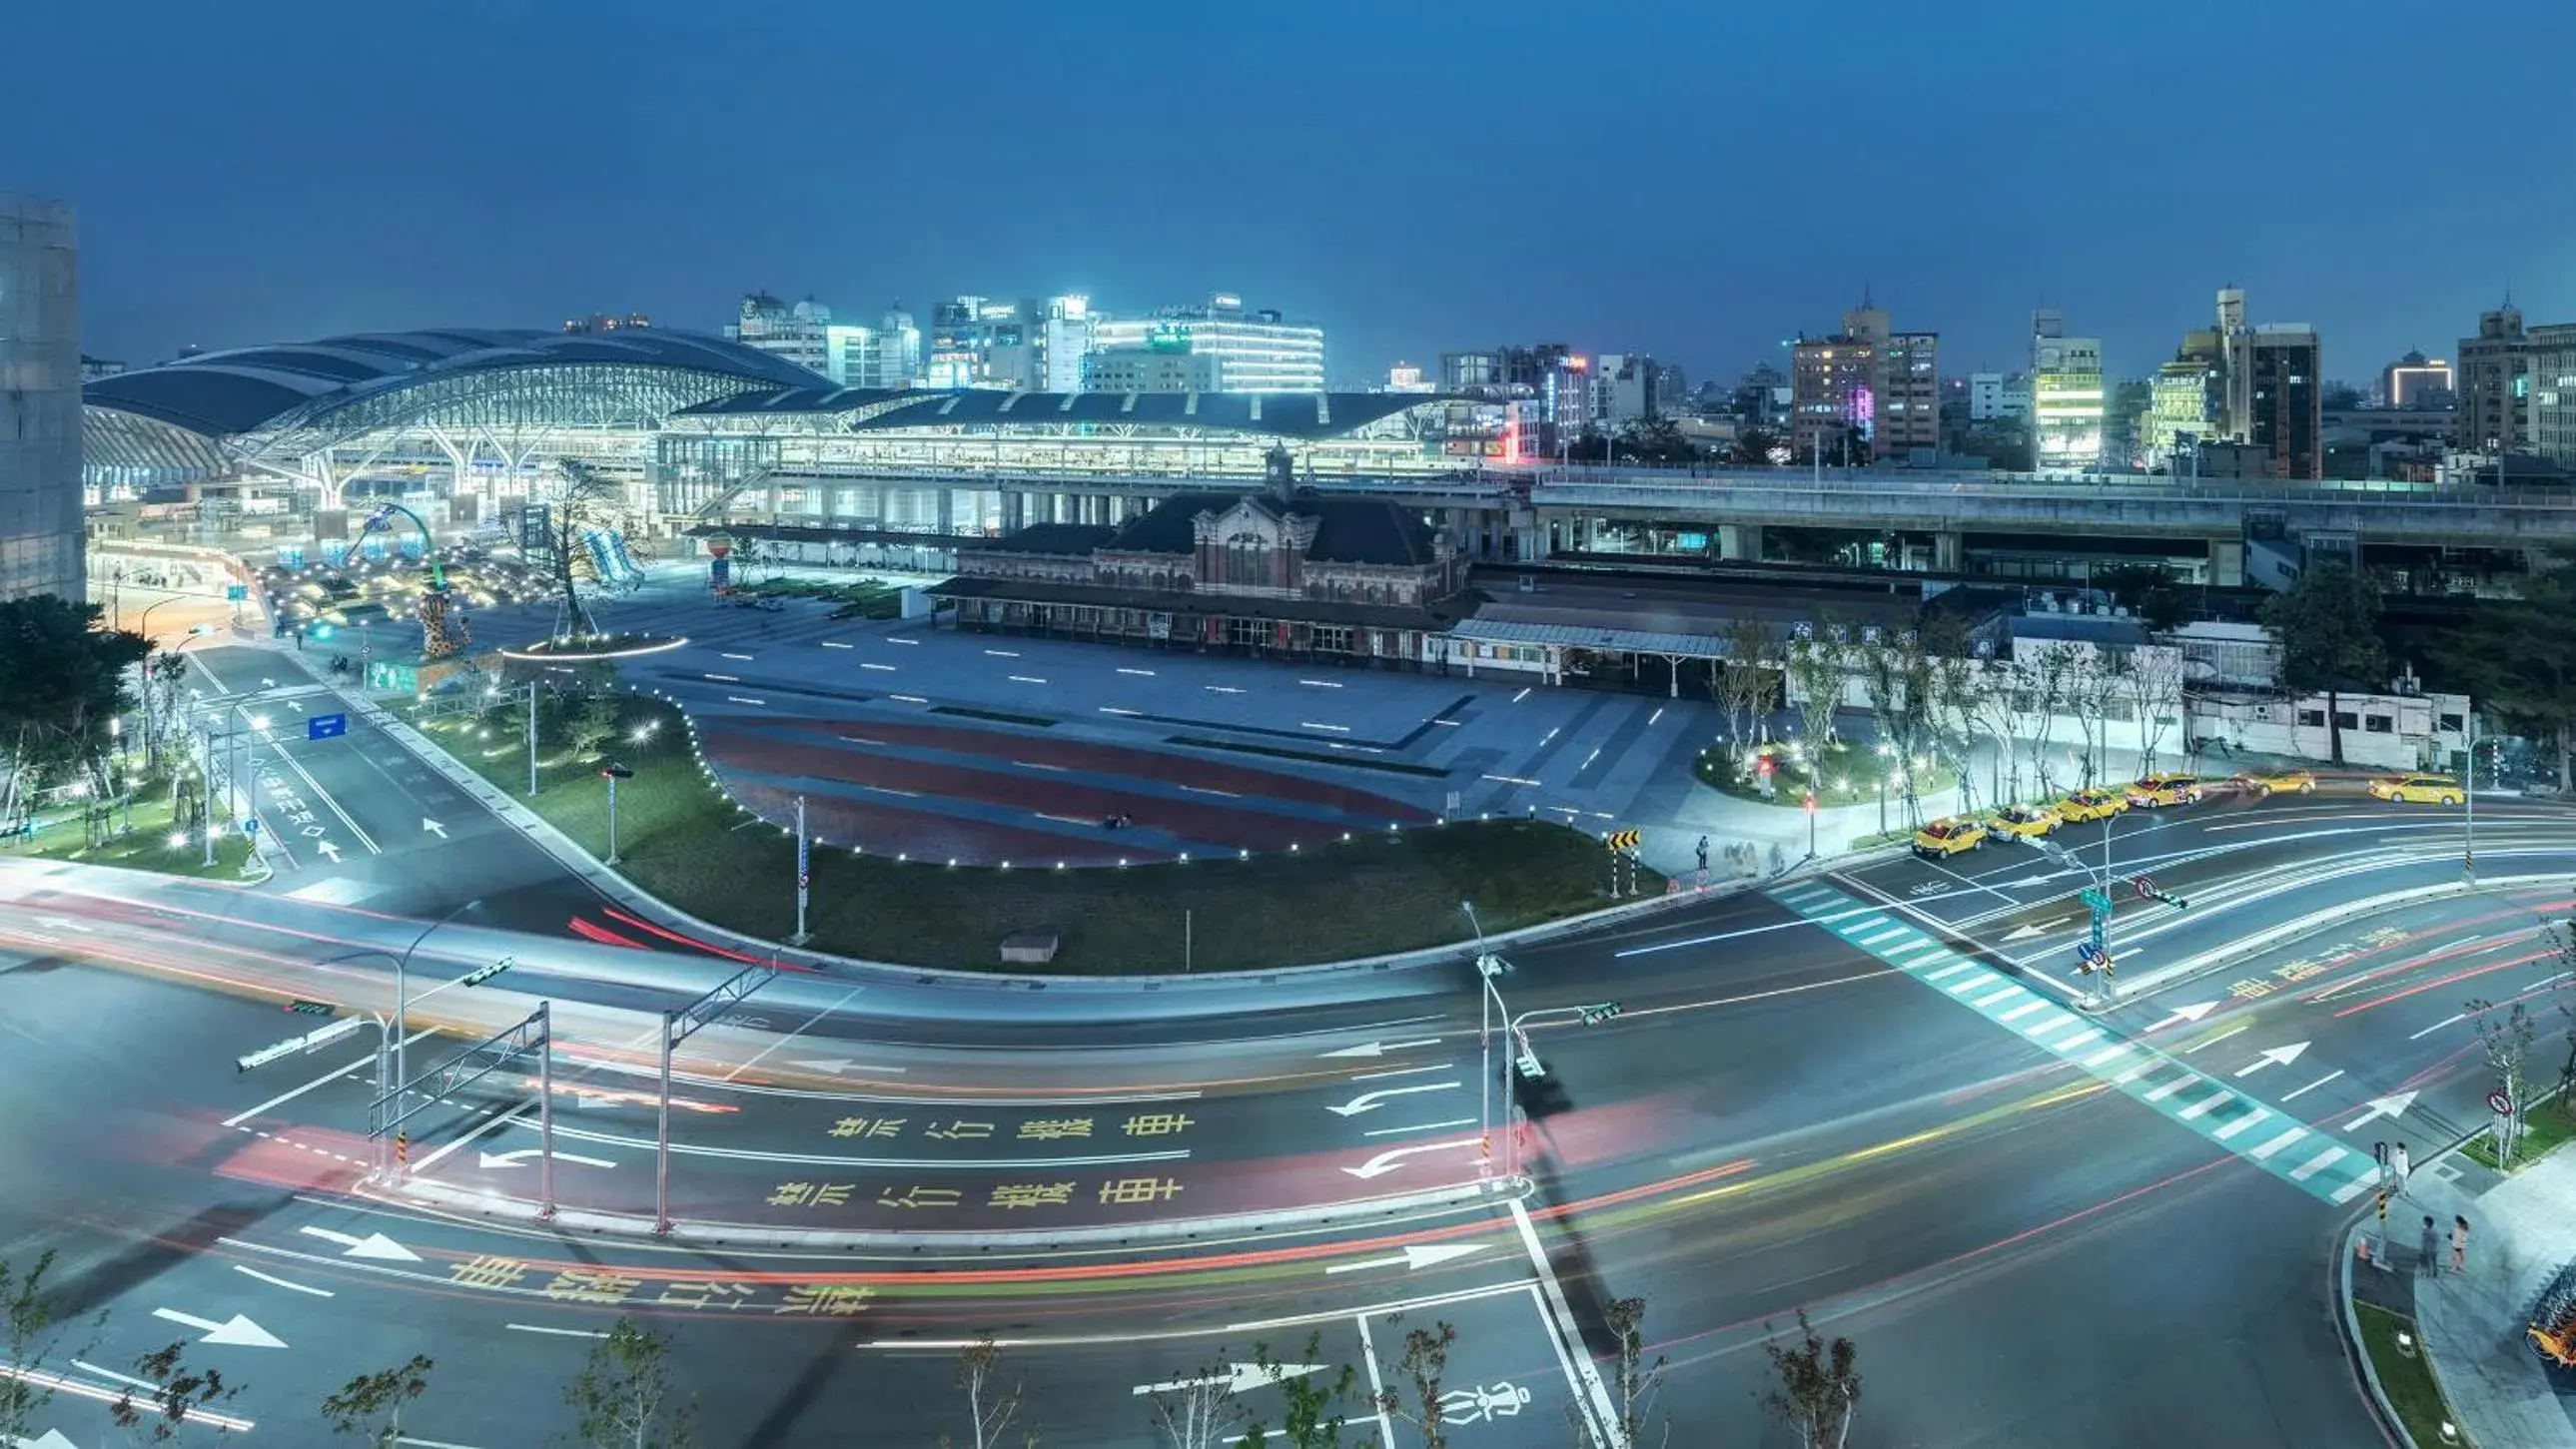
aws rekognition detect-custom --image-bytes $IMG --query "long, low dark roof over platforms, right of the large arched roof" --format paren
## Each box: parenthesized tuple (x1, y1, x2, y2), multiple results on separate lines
(672, 386, 1440, 442)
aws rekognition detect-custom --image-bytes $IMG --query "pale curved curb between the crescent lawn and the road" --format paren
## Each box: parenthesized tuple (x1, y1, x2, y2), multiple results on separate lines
(363, 682, 1827, 991)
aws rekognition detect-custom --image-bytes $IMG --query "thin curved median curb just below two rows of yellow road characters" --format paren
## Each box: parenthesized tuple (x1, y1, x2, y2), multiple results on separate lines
(389, 1178, 1533, 1256)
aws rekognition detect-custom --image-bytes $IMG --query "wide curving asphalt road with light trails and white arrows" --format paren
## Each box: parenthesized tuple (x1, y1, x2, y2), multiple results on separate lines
(0, 715, 2576, 1449)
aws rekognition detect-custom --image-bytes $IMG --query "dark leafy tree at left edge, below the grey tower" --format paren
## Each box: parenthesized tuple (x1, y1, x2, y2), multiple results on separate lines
(0, 594, 152, 821)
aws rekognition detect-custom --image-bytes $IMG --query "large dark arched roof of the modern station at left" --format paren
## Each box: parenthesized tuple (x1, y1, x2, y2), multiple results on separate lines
(83, 327, 817, 437)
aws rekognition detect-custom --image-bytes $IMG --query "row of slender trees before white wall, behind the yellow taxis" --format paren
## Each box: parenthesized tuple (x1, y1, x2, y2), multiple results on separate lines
(1710, 615, 2181, 826)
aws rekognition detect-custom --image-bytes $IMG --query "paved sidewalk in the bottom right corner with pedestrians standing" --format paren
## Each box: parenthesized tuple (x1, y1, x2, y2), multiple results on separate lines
(2344, 1150, 2576, 1449)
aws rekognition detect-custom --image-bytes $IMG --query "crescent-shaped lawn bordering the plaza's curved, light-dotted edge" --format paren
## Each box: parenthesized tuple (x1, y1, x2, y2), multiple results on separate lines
(423, 697, 1664, 976)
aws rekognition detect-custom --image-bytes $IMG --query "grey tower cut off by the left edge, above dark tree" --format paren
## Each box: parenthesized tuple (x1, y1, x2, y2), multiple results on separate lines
(0, 196, 88, 602)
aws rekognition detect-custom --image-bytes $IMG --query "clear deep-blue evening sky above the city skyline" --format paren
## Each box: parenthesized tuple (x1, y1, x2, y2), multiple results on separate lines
(0, 0, 2576, 386)
